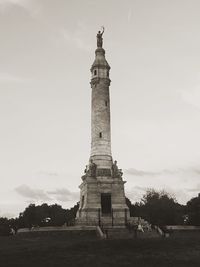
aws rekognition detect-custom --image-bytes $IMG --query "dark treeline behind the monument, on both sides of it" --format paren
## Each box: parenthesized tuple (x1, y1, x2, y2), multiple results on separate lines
(0, 189, 200, 235)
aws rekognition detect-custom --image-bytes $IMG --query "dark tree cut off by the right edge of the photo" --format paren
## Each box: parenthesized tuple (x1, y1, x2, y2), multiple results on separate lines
(186, 194, 200, 226)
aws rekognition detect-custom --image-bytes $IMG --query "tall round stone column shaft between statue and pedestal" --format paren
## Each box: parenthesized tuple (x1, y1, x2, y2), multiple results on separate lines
(91, 48, 112, 168)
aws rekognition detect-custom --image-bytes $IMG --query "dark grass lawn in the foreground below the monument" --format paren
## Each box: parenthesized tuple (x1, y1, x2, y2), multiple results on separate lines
(0, 235, 200, 267)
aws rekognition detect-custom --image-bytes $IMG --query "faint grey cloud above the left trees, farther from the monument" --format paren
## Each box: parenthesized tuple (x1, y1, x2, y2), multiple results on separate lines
(15, 185, 52, 201)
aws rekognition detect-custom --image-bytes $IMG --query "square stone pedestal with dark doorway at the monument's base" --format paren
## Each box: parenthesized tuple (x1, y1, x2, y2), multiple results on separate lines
(76, 176, 129, 227)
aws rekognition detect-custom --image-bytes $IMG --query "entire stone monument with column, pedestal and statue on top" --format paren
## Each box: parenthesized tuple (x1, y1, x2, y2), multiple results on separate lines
(76, 28, 129, 226)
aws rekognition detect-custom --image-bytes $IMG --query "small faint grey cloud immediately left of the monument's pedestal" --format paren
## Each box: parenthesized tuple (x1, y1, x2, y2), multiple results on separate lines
(47, 188, 79, 202)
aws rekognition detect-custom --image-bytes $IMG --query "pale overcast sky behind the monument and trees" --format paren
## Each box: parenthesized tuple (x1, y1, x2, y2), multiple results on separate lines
(0, 0, 200, 216)
